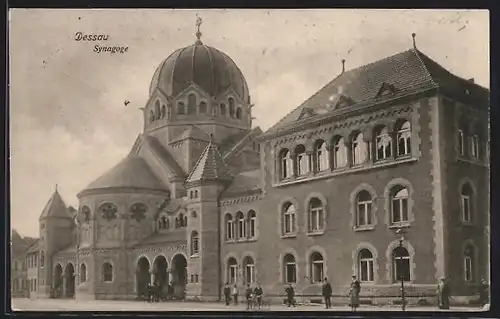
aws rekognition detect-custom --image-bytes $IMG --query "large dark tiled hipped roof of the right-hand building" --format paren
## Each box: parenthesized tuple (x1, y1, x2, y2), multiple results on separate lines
(264, 49, 489, 135)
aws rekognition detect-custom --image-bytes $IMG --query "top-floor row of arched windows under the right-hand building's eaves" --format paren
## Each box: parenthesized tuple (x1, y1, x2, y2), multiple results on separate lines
(279, 120, 411, 179)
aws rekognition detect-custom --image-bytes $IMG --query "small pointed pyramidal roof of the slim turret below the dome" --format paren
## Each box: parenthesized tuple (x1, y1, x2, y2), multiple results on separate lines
(186, 140, 232, 184)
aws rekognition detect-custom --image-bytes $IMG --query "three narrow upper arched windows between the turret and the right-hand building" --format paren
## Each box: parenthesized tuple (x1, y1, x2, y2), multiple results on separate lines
(224, 210, 257, 240)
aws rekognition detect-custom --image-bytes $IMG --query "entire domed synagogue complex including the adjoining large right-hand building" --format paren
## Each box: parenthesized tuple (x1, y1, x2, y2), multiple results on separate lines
(18, 26, 489, 300)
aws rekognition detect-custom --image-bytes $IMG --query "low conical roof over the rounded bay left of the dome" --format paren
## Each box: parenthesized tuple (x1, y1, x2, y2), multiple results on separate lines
(80, 154, 166, 195)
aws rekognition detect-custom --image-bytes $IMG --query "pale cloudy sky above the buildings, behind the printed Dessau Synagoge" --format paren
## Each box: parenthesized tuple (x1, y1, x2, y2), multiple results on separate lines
(9, 9, 489, 237)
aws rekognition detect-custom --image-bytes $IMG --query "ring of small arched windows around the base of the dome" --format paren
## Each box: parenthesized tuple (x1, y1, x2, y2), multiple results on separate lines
(148, 94, 243, 123)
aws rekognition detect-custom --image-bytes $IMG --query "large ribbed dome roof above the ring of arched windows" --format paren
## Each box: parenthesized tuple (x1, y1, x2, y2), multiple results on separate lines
(149, 41, 249, 103)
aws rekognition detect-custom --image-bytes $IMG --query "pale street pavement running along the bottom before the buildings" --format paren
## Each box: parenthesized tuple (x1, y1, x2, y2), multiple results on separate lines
(12, 298, 481, 312)
